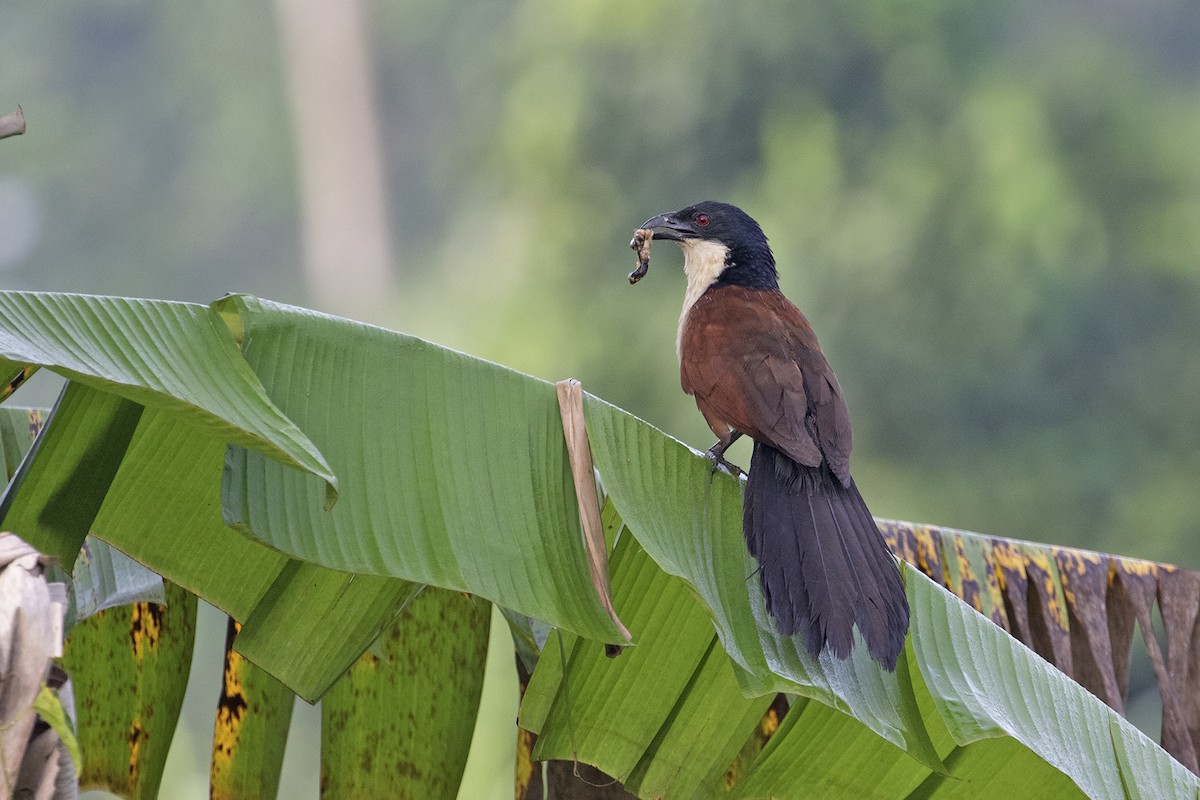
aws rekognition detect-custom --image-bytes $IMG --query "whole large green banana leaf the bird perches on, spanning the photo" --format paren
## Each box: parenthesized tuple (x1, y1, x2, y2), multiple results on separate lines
(0, 293, 1196, 796)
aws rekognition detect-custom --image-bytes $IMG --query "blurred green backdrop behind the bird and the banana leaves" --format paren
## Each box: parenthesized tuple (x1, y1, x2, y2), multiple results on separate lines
(0, 0, 1200, 798)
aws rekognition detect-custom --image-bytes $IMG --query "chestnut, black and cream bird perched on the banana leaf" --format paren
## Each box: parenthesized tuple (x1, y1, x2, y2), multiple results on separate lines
(640, 200, 910, 670)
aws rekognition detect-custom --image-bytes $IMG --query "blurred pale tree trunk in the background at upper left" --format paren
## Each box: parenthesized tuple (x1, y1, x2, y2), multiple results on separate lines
(276, 0, 392, 317)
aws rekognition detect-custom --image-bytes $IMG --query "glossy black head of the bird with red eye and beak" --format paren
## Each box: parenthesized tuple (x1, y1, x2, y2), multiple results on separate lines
(642, 200, 779, 289)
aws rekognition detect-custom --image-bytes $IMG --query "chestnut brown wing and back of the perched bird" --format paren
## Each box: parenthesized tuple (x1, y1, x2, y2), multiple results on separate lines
(680, 287, 852, 486)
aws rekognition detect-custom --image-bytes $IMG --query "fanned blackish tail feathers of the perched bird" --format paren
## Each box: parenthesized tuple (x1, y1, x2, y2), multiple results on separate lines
(743, 443, 908, 670)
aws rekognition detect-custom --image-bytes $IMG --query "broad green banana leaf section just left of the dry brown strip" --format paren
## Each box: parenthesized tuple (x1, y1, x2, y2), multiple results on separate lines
(217, 296, 623, 642)
